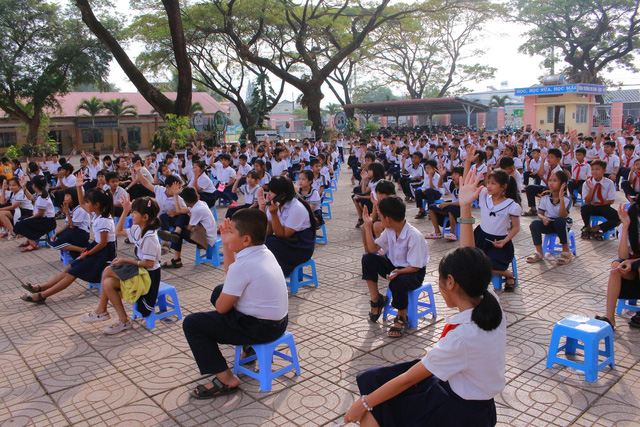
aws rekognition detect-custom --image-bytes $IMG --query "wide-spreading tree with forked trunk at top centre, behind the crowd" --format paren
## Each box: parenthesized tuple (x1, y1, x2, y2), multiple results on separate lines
(201, 0, 465, 135)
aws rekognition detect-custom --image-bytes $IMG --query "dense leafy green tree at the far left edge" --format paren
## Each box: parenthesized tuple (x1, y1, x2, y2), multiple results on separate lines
(0, 0, 111, 144)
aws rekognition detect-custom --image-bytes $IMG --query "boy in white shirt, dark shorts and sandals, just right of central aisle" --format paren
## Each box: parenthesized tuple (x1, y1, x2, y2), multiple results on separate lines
(362, 196, 429, 338)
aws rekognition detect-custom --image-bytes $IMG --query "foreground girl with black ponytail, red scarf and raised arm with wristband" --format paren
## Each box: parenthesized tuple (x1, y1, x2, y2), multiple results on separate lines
(344, 165, 507, 427)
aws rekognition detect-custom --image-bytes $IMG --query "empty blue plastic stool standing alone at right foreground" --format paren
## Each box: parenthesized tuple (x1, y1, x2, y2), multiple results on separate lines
(547, 314, 615, 382)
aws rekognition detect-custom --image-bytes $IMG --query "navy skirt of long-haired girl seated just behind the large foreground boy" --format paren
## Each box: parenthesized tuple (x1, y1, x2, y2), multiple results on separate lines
(265, 228, 316, 276)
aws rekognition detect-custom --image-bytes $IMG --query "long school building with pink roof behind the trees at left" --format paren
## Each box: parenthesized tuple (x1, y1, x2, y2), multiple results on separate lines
(0, 92, 228, 154)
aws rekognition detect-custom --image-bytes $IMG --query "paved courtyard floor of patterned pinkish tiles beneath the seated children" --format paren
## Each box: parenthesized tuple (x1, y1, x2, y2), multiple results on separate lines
(0, 171, 640, 427)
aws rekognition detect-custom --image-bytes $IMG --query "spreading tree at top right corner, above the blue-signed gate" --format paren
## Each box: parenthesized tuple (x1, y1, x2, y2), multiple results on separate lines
(511, 0, 640, 84)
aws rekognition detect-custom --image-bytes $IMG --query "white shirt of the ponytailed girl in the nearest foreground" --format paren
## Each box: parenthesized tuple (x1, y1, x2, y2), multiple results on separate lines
(422, 298, 507, 400)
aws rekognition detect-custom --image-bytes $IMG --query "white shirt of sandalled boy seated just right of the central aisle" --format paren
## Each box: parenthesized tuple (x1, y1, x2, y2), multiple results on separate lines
(376, 221, 430, 268)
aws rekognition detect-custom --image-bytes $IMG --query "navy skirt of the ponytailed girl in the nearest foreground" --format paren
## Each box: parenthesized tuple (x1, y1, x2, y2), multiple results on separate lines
(356, 360, 497, 427)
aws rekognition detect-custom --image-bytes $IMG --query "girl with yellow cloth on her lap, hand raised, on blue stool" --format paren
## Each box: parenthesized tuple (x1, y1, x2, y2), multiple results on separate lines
(82, 193, 162, 335)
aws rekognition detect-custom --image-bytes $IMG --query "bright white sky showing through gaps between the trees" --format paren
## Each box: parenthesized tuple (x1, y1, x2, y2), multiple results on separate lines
(109, 0, 640, 105)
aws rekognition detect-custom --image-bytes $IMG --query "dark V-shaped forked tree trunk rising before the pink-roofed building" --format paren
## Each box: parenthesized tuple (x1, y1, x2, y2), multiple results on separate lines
(74, 0, 192, 117)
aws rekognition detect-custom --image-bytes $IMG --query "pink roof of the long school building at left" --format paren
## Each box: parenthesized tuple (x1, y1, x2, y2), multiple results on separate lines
(0, 92, 229, 117)
